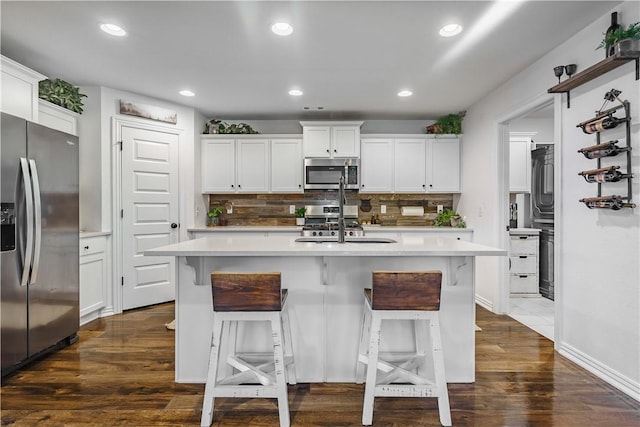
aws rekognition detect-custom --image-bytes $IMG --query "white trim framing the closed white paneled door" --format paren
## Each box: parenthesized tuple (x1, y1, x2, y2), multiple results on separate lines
(111, 115, 184, 314)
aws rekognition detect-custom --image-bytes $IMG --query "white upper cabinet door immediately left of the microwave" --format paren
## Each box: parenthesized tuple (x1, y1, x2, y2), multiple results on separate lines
(271, 138, 304, 193)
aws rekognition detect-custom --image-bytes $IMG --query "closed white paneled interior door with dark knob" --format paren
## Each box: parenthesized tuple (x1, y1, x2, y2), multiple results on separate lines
(121, 125, 179, 310)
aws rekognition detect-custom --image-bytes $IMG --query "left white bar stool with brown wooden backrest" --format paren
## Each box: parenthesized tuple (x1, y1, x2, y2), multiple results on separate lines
(200, 272, 296, 427)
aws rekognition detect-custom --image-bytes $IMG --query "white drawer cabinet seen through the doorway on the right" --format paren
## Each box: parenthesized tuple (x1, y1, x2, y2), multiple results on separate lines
(509, 228, 540, 296)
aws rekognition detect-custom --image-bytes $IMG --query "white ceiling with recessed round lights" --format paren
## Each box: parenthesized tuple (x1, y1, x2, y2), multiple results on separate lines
(0, 1, 619, 119)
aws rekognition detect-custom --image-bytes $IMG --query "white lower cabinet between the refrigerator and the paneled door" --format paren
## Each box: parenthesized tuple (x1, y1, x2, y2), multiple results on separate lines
(80, 236, 108, 325)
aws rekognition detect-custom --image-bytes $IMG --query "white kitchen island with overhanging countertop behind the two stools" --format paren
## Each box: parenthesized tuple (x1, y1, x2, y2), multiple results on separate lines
(144, 236, 507, 383)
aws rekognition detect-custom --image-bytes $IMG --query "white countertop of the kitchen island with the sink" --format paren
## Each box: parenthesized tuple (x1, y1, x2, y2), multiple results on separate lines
(144, 235, 507, 257)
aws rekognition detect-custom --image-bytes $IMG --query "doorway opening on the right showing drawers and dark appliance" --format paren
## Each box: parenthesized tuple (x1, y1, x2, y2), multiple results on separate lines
(504, 99, 556, 341)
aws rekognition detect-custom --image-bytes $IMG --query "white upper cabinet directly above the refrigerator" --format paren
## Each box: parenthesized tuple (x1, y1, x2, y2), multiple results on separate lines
(0, 55, 47, 123)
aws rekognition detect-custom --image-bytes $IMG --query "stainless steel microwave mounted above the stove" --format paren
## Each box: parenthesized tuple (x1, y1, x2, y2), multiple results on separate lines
(304, 158, 360, 190)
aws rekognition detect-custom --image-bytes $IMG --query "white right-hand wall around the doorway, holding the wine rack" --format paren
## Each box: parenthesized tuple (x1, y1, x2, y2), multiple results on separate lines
(459, 1, 640, 399)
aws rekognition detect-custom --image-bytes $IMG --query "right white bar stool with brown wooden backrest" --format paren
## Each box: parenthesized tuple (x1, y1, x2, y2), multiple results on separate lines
(356, 271, 451, 426)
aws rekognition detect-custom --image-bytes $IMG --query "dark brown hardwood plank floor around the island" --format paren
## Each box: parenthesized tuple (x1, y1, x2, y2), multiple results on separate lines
(0, 304, 640, 427)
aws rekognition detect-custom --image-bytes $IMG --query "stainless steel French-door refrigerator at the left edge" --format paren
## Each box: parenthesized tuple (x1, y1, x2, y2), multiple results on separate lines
(0, 113, 79, 376)
